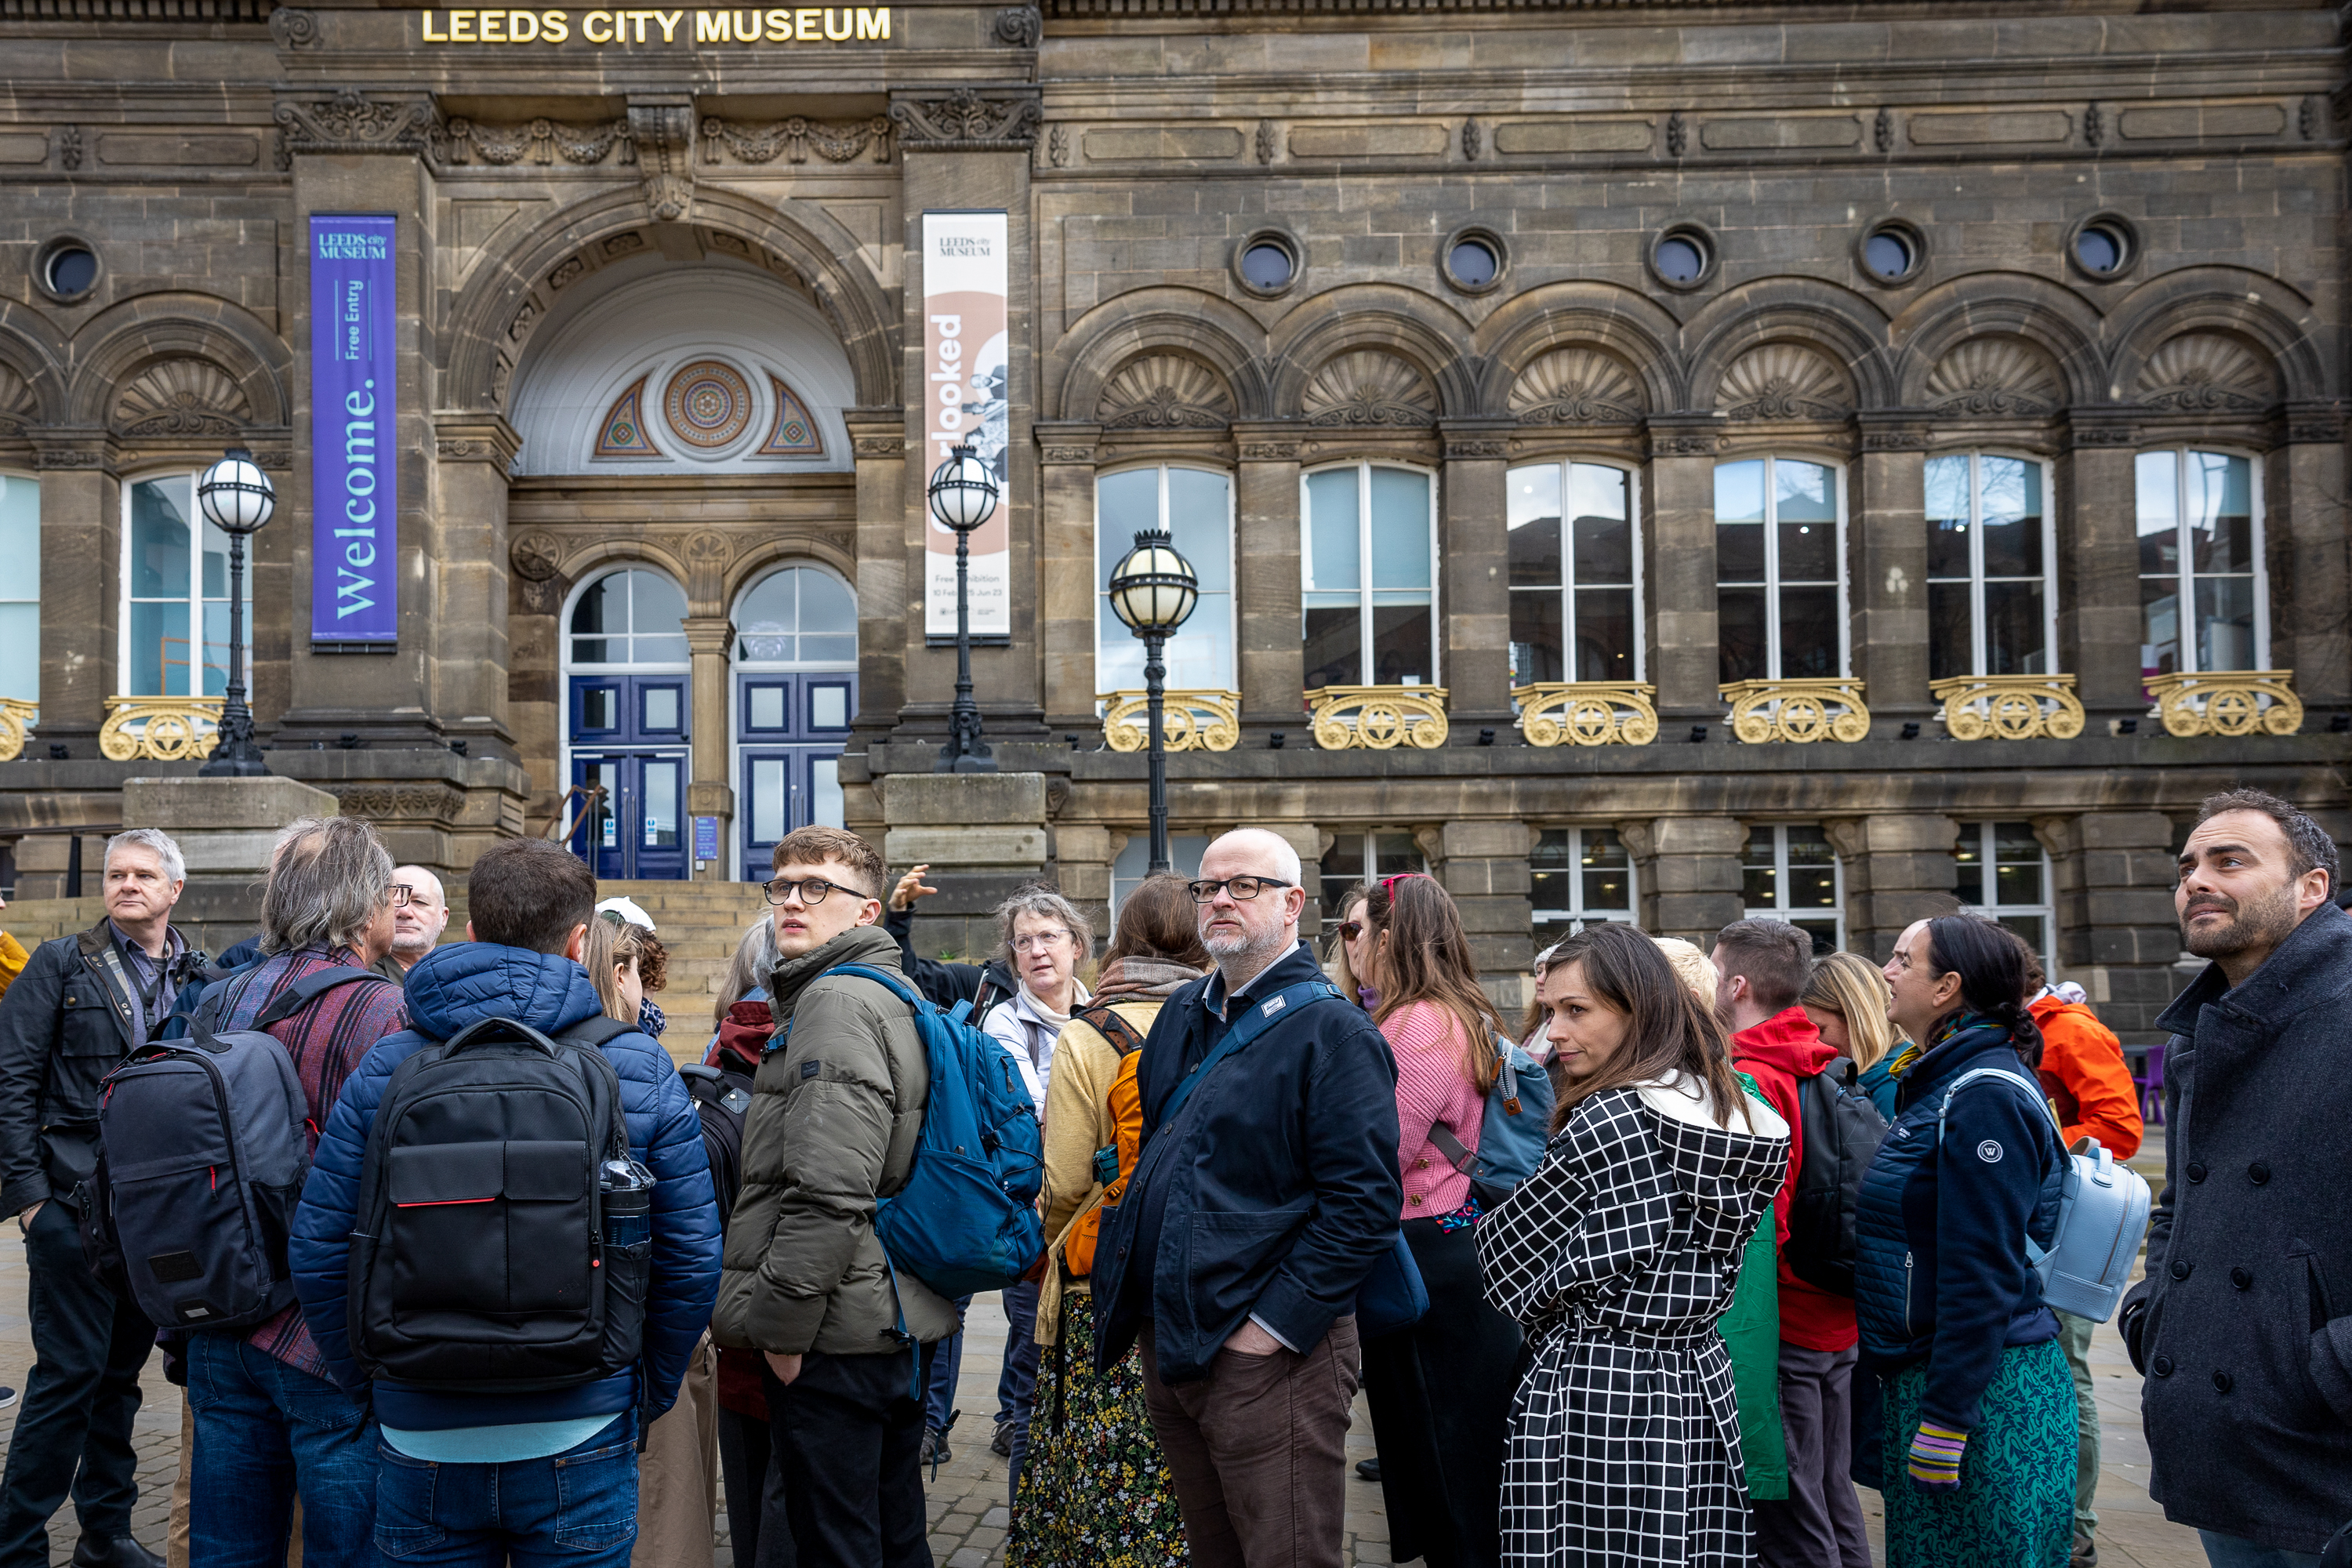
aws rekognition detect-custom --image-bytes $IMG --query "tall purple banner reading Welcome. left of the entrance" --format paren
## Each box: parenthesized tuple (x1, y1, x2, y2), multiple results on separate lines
(310, 214, 400, 642)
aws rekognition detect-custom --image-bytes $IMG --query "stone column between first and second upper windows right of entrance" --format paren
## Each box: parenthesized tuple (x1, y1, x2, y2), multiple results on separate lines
(1232, 423, 1322, 747)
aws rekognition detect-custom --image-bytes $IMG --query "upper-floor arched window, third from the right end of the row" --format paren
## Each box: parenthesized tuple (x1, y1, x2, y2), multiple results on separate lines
(1715, 456, 1846, 684)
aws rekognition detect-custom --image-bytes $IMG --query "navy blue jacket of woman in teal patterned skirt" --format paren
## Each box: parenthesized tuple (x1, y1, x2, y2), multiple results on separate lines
(1853, 1018, 2063, 1432)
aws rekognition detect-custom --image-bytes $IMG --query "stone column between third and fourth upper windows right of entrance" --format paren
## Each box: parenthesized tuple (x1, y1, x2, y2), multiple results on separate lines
(1642, 414, 1738, 728)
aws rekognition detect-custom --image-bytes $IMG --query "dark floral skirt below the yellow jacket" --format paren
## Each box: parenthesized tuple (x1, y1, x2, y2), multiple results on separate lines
(1004, 1290, 1190, 1568)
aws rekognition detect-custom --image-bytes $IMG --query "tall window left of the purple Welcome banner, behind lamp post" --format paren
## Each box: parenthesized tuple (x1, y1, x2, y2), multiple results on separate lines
(120, 473, 254, 696)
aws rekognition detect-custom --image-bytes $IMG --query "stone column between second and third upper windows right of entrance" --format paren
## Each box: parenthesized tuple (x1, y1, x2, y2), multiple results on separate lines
(1437, 419, 1524, 742)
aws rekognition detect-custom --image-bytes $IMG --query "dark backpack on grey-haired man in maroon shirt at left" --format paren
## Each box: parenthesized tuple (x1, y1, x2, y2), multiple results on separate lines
(80, 966, 388, 1328)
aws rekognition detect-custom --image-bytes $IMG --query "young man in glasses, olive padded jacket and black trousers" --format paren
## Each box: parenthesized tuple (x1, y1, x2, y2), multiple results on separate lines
(713, 827, 955, 1568)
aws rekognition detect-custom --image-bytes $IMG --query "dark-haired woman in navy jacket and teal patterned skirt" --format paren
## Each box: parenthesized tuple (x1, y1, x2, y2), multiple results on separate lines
(1853, 914, 2074, 1568)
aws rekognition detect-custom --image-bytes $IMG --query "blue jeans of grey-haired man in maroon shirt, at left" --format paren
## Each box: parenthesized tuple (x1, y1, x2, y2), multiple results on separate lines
(188, 1333, 376, 1568)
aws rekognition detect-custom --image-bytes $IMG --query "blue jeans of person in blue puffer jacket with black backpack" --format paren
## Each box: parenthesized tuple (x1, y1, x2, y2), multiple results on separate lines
(372, 1415, 637, 1568)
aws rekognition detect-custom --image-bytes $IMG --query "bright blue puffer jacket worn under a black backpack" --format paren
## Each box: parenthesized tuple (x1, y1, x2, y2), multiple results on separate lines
(287, 942, 720, 1432)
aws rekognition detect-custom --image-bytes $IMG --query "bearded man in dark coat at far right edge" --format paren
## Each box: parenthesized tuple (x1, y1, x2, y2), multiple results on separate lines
(2119, 789, 2352, 1568)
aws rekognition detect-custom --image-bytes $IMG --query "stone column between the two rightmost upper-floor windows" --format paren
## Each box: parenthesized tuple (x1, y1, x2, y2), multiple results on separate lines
(2056, 409, 2147, 734)
